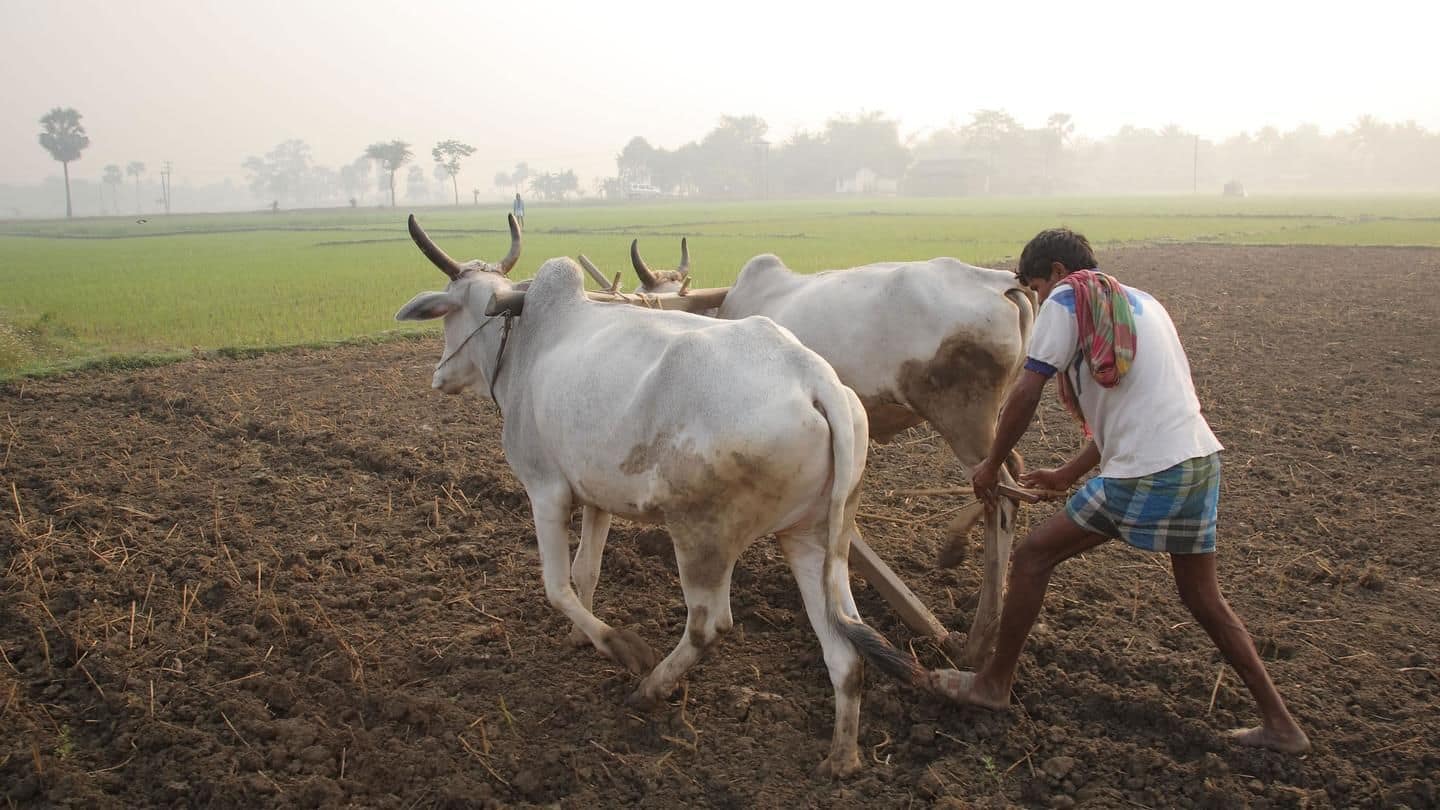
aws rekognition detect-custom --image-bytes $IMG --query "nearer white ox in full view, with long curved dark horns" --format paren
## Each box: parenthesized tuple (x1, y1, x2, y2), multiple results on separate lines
(396, 216, 933, 775)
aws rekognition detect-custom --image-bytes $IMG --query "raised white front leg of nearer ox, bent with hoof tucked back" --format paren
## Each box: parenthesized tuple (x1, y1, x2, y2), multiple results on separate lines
(530, 496, 655, 675)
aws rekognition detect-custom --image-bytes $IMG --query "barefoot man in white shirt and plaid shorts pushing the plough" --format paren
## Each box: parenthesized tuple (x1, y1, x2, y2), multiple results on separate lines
(936, 228, 1310, 752)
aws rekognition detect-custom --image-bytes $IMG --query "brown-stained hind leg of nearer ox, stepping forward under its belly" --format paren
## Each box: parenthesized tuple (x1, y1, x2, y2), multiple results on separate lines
(629, 526, 739, 708)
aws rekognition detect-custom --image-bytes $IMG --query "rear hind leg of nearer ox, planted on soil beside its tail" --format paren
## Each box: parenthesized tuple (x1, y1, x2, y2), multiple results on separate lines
(779, 528, 864, 777)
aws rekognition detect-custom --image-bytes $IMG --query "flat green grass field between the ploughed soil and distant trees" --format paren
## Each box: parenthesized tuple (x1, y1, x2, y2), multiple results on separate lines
(0, 196, 1440, 378)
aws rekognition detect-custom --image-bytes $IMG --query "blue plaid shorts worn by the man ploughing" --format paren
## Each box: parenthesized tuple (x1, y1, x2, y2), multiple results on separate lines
(1066, 453, 1220, 553)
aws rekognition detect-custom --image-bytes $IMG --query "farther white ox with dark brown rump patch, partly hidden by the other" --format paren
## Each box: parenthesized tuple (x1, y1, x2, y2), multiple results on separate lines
(630, 241, 1035, 664)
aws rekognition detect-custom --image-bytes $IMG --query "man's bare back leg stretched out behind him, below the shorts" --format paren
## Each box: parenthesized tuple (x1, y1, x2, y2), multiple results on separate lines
(1171, 553, 1310, 754)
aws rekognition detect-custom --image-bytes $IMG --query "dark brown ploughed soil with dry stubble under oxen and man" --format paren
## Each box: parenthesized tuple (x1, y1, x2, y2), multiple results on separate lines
(0, 246, 1440, 807)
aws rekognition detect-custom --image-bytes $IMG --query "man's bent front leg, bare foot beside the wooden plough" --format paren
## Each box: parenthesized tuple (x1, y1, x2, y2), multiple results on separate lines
(930, 512, 1109, 709)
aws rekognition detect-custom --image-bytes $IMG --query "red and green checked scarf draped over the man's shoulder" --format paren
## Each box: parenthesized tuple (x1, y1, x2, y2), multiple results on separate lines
(1060, 270, 1135, 437)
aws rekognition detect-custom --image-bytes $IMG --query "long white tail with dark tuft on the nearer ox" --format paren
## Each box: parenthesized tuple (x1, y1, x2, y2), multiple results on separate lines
(815, 385, 929, 687)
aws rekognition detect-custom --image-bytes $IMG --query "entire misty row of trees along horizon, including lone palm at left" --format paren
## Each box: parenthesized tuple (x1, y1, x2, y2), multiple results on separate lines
(19, 107, 1440, 216)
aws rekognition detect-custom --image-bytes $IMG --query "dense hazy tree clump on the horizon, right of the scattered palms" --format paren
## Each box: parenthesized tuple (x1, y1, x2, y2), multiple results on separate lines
(613, 110, 1440, 197)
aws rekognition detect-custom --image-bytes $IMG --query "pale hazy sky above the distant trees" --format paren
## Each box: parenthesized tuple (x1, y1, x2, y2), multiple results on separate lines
(0, 0, 1440, 192)
